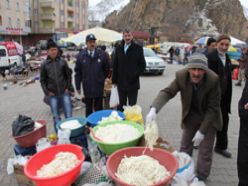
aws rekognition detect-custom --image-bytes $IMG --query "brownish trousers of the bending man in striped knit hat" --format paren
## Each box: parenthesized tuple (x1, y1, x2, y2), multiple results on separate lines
(180, 116, 216, 180)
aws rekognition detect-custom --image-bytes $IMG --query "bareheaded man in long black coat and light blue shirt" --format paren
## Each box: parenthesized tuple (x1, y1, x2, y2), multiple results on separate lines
(112, 30, 146, 111)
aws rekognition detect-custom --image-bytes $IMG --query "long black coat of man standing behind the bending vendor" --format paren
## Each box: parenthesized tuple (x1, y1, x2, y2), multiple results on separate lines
(207, 49, 232, 113)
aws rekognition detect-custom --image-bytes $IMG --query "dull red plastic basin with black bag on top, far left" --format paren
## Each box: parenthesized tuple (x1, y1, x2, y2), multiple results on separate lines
(13, 120, 47, 147)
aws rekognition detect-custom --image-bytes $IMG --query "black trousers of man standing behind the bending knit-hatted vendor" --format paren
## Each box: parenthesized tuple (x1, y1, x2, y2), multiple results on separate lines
(215, 104, 229, 150)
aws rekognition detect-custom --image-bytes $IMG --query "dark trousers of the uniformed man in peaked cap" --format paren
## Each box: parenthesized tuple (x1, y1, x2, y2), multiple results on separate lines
(85, 97, 103, 117)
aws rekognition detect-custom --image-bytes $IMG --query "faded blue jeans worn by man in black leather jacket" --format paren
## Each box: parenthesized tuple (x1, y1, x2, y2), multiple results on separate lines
(49, 93, 72, 132)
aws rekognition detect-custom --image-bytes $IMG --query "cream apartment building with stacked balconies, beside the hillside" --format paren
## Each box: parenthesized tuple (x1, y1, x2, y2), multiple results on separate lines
(25, 0, 88, 45)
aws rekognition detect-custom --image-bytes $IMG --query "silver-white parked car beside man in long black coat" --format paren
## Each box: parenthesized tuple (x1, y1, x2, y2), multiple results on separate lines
(143, 48, 165, 75)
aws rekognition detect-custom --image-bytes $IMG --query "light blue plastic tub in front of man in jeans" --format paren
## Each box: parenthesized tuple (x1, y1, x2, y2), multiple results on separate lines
(57, 117, 87, 137)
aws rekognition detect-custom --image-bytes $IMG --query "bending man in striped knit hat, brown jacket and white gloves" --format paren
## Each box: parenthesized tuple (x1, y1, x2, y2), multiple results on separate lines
(146, 53, 222, 181)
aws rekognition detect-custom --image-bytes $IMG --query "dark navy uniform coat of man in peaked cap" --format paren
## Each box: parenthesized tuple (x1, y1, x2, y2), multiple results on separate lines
(75, 49, 110, 98)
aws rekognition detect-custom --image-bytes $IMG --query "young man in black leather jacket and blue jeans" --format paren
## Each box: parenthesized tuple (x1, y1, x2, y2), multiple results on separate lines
(40, 39, 74, 131)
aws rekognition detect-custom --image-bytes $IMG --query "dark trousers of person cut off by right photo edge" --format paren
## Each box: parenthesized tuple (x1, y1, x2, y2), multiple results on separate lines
(237, 118, 248, 186)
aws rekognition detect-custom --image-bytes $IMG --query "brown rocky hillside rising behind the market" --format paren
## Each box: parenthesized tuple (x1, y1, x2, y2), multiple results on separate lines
(104, 0, 248, 41)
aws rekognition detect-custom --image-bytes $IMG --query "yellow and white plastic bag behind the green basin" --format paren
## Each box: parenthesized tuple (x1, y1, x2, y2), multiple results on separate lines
(123, 105, 144, 125)
